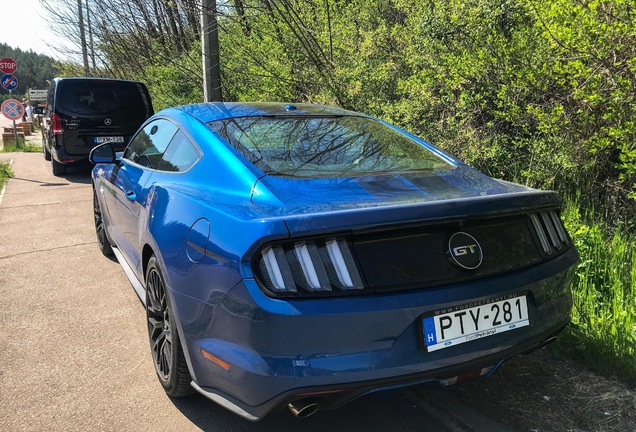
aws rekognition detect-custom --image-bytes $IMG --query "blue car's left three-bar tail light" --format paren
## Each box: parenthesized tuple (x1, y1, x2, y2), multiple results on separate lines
(255, 239, 364, 296)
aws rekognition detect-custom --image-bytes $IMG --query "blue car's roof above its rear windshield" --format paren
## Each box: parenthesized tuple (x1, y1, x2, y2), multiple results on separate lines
(176, 102, 360, 123)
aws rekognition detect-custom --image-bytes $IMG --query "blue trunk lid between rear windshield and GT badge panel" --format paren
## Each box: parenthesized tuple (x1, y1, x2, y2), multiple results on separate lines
(252, 164, 560, 236)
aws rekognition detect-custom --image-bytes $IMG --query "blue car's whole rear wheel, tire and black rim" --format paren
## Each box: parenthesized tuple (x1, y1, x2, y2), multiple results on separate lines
(146, 255, 194, 397)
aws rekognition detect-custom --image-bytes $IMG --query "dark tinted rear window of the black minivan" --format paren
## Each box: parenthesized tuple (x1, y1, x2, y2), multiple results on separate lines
(59, 80, 152, 117)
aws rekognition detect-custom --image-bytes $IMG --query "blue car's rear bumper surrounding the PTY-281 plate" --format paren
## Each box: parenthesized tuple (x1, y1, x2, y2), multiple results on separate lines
(172, 248, 578, 420)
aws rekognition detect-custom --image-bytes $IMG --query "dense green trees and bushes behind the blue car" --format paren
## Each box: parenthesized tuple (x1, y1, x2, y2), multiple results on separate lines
(36, 0, 636, 220)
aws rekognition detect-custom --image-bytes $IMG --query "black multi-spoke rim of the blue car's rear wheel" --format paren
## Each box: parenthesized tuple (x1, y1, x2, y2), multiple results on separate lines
(146, 268, 172, 381)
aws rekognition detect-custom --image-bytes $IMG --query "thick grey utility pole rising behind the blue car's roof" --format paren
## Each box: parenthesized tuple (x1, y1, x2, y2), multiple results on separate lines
(201, 0, 223, 102)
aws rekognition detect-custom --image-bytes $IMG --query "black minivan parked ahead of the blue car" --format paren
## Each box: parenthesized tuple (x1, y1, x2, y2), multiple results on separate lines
(42, 78, 154, 176)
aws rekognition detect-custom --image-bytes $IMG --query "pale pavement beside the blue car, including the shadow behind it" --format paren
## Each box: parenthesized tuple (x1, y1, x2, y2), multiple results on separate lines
(0, 153, 509, 432)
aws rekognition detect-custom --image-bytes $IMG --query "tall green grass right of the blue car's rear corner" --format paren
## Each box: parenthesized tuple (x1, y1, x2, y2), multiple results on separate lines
(559, 197, 636, 385)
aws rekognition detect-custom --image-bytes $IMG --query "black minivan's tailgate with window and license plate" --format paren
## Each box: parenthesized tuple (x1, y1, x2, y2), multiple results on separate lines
(55, 79, 153, 156)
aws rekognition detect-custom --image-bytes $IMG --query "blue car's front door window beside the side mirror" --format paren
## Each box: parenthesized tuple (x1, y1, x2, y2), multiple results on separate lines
(124, 119, 177, 169)
